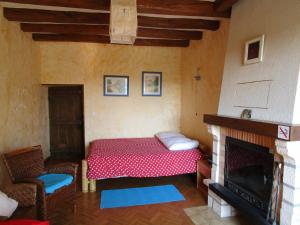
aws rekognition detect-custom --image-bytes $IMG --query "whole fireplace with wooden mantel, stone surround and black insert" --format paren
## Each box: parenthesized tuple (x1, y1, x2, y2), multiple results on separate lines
(204, 115, 300, 225)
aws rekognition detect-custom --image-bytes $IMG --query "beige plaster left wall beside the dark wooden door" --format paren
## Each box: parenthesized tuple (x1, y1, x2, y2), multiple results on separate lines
(0, 5, 49, 186)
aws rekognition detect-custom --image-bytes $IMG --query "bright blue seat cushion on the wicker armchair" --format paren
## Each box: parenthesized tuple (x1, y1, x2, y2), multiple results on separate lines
(37, 173, 73, 194)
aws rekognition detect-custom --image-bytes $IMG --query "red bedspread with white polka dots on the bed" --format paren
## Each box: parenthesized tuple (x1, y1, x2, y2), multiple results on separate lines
(87, 138, 202, 180)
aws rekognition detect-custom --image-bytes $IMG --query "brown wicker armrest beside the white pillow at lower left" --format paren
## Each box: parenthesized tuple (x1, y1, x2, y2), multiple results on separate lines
(4, 183, 36, 207)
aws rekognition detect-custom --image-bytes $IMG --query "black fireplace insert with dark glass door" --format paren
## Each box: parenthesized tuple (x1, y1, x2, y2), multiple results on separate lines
(224, 137, 274, 217)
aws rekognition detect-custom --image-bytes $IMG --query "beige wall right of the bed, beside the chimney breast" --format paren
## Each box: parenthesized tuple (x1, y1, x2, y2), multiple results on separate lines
(181, 20, 229, 152)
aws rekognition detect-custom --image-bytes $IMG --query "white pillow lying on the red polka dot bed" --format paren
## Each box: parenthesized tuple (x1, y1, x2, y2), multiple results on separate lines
(159, 136, 199, 151)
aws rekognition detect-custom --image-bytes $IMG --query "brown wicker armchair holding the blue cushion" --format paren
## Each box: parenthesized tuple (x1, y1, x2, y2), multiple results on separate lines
(3, 146, 78, 220)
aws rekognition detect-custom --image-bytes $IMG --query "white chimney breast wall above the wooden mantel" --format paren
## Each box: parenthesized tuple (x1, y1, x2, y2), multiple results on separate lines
(218, 0, 300, 123)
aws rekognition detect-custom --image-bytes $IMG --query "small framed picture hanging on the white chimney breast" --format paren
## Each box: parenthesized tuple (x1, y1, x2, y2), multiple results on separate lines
(244, 35, 265, 64)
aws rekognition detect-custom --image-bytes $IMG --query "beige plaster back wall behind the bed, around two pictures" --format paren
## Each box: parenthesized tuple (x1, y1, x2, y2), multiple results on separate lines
(39, 43, 181, 150)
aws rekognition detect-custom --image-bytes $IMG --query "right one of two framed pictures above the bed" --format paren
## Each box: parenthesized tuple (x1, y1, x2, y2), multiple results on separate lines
(142, 72, 162, 96)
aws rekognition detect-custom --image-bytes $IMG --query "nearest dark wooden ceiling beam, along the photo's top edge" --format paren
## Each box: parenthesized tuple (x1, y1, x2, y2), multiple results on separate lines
(0, 0, 231, 18)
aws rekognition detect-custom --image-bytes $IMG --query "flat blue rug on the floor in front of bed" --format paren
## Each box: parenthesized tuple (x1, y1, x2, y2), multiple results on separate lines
(100, 185, 185, 209)
